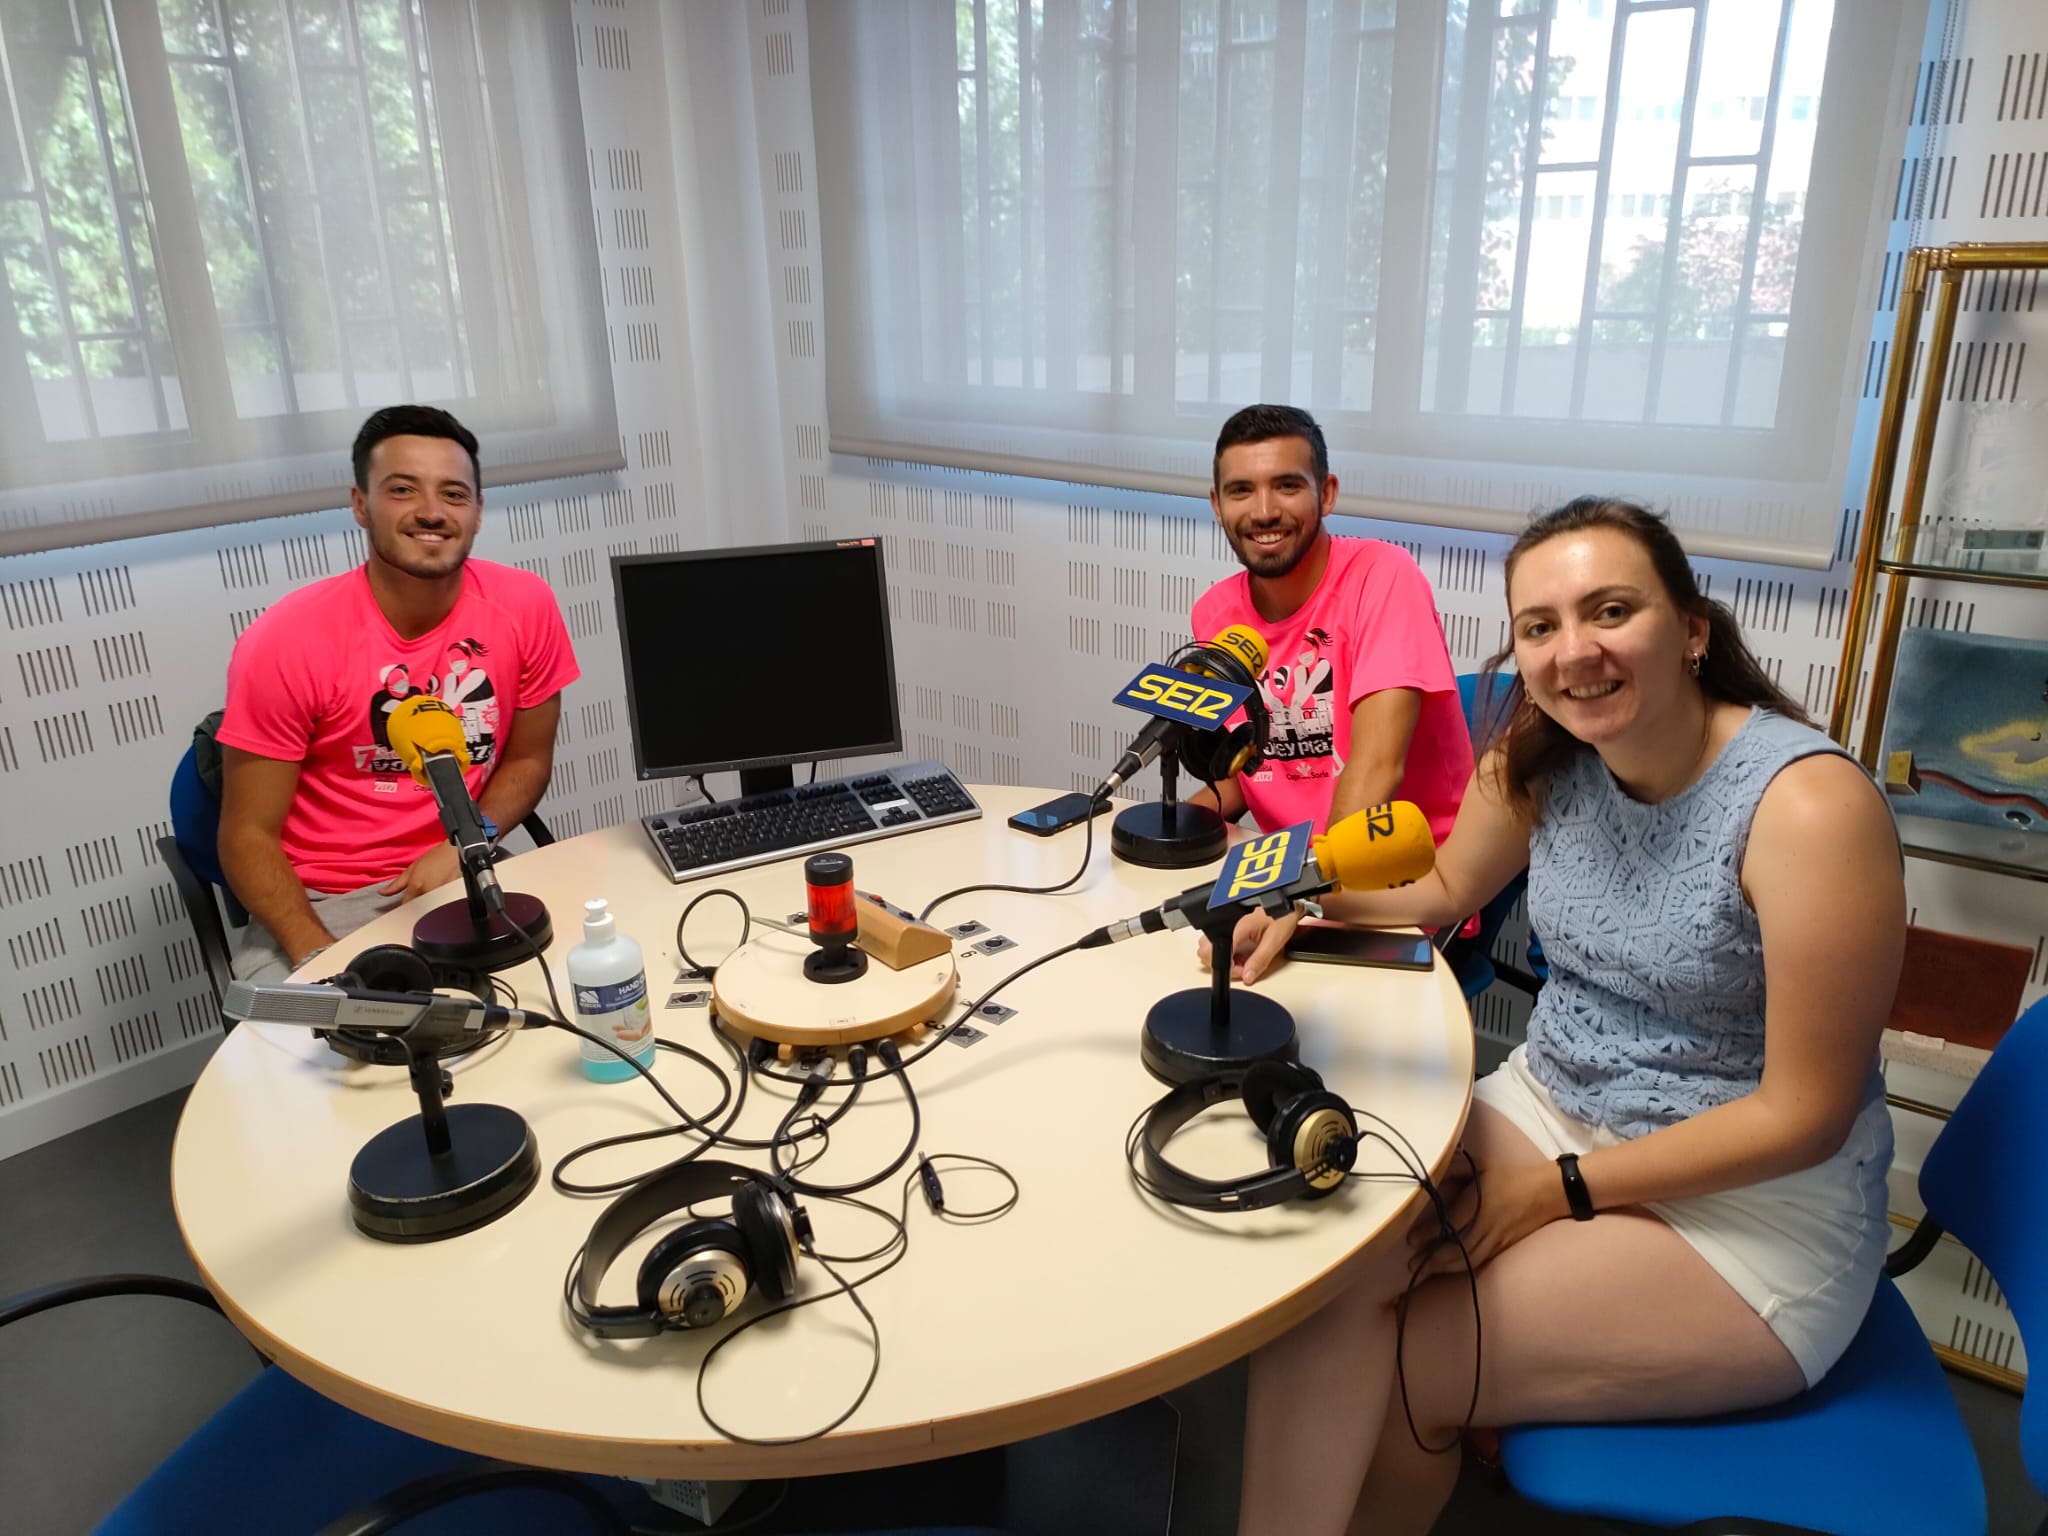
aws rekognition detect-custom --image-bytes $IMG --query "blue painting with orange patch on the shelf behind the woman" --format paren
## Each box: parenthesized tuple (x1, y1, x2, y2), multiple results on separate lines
(1884, 629, 2048, 831)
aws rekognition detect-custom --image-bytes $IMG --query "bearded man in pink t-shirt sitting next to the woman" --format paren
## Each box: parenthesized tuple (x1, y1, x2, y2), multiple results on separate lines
(1192, 406, 1473, 844)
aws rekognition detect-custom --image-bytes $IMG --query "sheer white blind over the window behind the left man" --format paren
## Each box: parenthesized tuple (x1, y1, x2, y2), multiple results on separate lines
(0, 0, 623, 555)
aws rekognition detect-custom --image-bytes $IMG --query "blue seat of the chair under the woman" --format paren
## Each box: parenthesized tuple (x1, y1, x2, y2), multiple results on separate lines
(1501, 1276, 1987, 1536)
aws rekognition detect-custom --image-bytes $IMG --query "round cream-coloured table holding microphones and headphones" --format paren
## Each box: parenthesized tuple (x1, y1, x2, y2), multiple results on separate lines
(172, 786, 1473, 1477)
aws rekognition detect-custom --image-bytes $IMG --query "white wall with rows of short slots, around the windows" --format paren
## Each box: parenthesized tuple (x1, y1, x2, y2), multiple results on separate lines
(0, 0, 2048, 1364)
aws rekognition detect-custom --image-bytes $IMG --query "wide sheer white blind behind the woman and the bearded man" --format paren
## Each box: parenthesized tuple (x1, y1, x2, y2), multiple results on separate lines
(809, 0, 1925, 565)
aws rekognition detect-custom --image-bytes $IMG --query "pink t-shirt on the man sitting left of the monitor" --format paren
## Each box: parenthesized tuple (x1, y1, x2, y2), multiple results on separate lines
(219, 559, 578, 891)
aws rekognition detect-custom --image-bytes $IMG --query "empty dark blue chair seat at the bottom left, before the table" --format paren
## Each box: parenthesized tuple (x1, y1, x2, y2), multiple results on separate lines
(98, 1366, 647, 1536)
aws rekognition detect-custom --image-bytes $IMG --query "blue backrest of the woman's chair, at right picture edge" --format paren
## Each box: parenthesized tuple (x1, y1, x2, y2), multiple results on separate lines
(1919, 997, 2048, 1493)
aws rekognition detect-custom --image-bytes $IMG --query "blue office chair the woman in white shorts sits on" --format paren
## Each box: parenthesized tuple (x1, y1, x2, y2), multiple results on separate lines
(1501, 999, 2048, 1536)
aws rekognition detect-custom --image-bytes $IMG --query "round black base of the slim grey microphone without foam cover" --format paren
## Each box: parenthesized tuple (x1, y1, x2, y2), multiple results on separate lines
(348, 1104, 541, 1243)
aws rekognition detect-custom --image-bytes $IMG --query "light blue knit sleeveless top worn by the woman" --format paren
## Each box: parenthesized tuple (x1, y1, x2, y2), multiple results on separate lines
(1528, 709, 1875, 1137)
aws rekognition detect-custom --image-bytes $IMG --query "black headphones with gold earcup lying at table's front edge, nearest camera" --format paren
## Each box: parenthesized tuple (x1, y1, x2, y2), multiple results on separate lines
(565, 1161, 811, 1339)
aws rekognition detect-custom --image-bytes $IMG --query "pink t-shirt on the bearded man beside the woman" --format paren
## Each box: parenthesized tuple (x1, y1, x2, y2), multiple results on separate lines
(1192, 539, 1473, 844)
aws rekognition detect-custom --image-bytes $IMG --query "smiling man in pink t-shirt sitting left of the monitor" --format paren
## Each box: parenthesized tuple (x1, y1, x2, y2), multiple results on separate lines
(217, 406, 578, 979)
